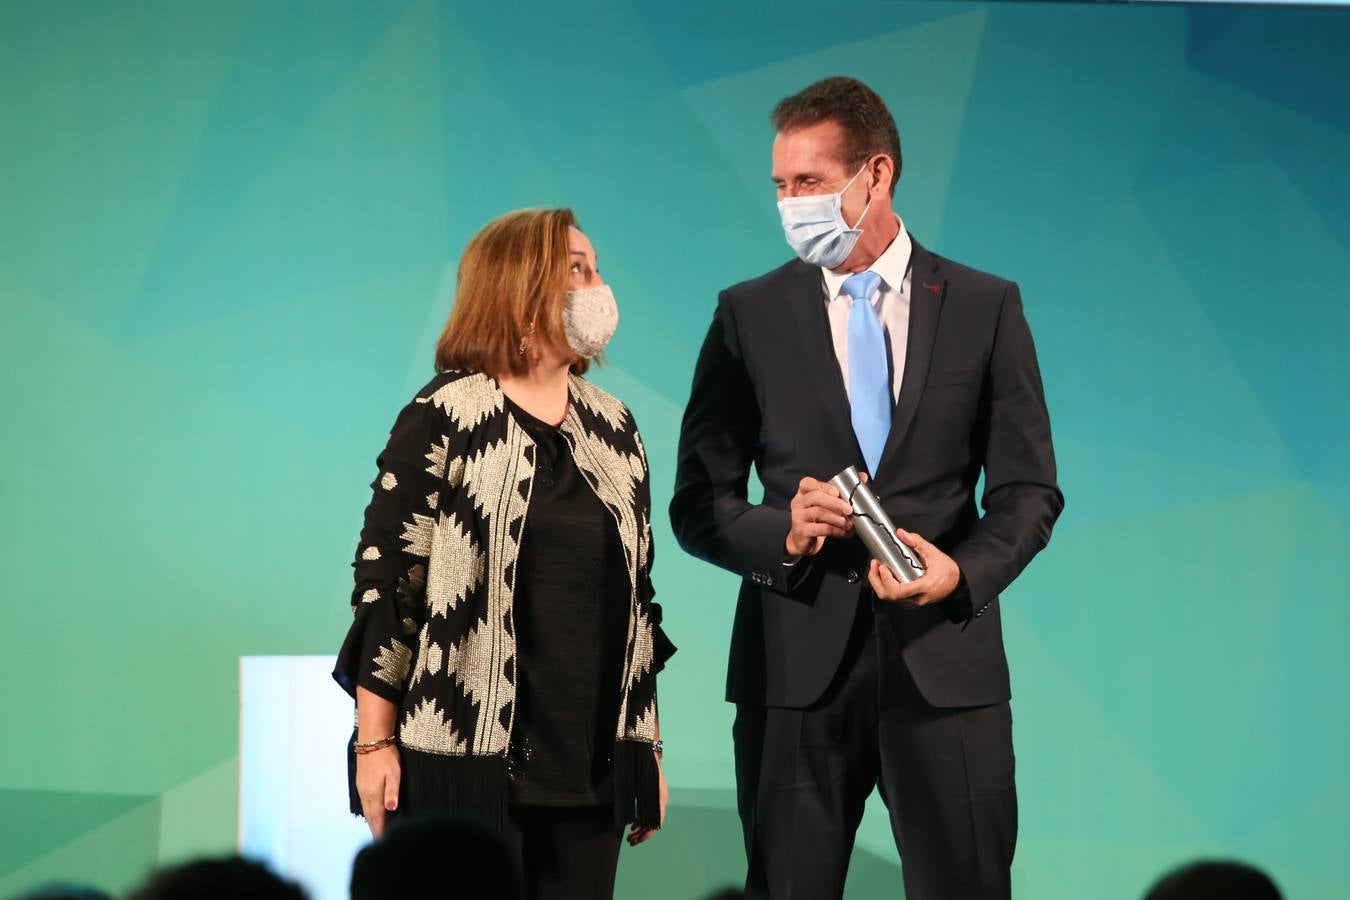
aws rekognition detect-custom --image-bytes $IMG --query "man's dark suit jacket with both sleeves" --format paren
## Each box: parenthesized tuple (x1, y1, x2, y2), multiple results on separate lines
(671, 242, 1064, 707)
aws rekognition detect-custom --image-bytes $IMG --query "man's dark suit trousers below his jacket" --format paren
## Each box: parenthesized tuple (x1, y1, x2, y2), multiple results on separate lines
(733, 594, 1017, 900)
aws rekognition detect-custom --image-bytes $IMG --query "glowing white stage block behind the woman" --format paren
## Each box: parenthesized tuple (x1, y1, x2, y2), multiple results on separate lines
(239, 656, 370, 900)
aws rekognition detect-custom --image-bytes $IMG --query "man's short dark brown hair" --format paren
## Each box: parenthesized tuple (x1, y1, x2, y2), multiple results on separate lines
(770, 77, 902, 196)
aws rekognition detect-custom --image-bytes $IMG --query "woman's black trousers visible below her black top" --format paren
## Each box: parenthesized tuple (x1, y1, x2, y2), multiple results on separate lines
(508, 804, 624, 900)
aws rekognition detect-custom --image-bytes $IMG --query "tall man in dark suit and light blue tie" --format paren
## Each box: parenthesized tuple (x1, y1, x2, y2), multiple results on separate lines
(671, 78, 1064, 900)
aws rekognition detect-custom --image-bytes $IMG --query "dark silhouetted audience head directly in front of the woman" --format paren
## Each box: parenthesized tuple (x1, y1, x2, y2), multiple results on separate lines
(351, 815, 525, 900)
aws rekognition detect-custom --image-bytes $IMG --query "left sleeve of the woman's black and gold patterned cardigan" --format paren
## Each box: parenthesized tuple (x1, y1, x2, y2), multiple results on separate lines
(333, 401, 446, 703)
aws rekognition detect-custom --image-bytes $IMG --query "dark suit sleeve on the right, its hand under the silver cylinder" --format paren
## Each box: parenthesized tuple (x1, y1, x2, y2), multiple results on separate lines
(950, 283, 1064, 615)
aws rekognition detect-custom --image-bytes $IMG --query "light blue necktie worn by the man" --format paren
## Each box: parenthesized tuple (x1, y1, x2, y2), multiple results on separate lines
(844, 271, 891, 478)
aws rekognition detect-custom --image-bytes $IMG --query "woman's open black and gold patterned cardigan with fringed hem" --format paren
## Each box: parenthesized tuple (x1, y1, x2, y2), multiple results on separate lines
(333, 372, 675, 826)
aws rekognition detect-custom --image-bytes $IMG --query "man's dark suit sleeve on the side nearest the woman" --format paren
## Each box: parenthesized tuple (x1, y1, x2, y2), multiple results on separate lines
(671, 291, 809, 594)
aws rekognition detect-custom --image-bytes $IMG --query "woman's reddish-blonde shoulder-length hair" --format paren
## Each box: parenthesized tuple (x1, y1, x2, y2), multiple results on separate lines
(436, 209, 589, 376)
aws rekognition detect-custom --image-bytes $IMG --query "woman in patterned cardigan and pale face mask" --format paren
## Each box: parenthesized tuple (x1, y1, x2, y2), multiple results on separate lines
(333, 209, 675, 897)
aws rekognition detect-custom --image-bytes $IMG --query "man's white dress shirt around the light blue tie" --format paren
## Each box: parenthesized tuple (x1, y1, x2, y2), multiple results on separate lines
(821, 216, 913, 402)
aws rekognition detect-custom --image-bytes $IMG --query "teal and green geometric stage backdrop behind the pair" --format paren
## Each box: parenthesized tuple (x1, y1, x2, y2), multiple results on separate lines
(0, 0, 1350, 900)
